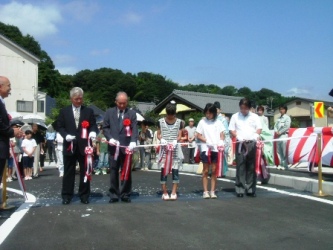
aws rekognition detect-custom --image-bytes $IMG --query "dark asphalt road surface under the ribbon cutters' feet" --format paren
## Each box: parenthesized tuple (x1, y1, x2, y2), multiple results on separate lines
(0, 166, 333, 250)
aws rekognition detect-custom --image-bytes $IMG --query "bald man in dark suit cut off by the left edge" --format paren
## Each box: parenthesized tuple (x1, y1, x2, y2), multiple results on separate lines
(0, 76, 23, 184)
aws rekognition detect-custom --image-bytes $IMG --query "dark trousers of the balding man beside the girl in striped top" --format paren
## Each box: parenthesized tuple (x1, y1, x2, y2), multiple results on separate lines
(109, 150, 132, 199)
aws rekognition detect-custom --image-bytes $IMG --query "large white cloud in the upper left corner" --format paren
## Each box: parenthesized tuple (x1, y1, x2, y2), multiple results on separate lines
(0, 1, 62, 38)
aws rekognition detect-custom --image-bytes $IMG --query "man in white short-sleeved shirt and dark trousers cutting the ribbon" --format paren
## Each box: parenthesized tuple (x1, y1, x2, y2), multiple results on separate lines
(229, 98, 262, 197)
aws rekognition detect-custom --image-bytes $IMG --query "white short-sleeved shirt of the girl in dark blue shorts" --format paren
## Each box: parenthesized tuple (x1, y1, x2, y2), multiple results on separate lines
(196, 118, 225, 152)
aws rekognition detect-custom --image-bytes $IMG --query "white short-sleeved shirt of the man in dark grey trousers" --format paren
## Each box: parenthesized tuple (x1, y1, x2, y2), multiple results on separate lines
(229, 111, 262, 140)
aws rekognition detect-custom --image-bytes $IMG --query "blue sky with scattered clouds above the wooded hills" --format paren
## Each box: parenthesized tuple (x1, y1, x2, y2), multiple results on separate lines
(0, 0, 333, 101)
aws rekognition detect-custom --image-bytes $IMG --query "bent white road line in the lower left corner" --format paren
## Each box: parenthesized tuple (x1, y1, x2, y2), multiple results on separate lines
(0, 188, 36, 245)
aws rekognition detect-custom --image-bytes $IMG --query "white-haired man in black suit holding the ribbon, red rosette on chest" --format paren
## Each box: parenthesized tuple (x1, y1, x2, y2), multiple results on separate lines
(57, 87, 98, 205)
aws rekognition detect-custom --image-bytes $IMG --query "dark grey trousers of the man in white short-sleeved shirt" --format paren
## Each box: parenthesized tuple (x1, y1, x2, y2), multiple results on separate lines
(235, 141, 257, 194)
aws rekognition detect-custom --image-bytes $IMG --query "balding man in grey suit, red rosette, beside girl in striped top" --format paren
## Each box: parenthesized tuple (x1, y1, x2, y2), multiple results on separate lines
(103, 92, 138, 203)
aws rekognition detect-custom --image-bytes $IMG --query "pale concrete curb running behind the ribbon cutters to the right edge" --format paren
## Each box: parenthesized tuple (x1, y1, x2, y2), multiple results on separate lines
(151, 163, 333, 196)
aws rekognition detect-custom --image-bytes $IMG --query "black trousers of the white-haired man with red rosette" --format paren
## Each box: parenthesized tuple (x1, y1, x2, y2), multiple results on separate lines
(61, 149, 90, 200)
